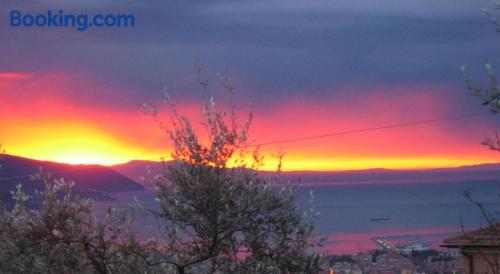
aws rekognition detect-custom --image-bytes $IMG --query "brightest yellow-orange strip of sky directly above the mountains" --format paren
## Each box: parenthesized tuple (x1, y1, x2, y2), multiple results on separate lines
(0, 108, 498, 171)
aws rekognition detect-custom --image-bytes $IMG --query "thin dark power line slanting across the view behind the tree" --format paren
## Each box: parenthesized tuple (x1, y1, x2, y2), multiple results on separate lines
(0, 113, 481, 182)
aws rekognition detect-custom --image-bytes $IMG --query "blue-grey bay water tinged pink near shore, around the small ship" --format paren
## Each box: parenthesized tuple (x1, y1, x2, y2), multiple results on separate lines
(97, 181, 500, 253)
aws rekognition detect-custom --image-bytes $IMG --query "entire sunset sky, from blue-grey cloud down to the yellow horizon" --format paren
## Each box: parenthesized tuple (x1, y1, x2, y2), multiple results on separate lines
(0, 0, 500, 170)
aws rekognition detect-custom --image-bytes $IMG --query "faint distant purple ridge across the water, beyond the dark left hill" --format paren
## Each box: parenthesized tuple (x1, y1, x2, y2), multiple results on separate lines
(111, 161, 500, 187)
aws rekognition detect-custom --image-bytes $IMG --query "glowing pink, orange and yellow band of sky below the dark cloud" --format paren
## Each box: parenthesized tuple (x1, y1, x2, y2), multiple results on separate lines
(0, 73, 500, 170)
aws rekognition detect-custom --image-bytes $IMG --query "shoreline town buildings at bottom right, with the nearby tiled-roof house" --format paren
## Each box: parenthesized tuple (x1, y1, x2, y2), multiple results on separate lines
(330, 224, 500, 274)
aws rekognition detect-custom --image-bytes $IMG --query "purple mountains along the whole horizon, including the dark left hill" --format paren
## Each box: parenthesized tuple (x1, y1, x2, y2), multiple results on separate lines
(0, 155, 500, 196)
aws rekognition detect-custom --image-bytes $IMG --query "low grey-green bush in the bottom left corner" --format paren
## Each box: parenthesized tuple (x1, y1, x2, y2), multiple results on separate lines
(0, 173, 149, 273)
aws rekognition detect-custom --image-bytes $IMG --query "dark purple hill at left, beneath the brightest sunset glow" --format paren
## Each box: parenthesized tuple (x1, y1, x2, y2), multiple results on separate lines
(0, 155, 144, 196)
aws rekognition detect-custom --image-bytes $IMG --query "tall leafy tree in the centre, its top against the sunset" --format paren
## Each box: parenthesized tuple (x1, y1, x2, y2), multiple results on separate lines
(140, 71, 321, 273)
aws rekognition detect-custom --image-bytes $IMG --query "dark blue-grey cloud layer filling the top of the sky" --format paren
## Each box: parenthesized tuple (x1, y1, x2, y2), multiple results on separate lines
(0, 0, 500, 107)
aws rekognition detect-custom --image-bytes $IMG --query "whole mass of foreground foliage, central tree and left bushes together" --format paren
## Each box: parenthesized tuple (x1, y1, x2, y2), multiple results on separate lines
(0, 71, 322, 274)
